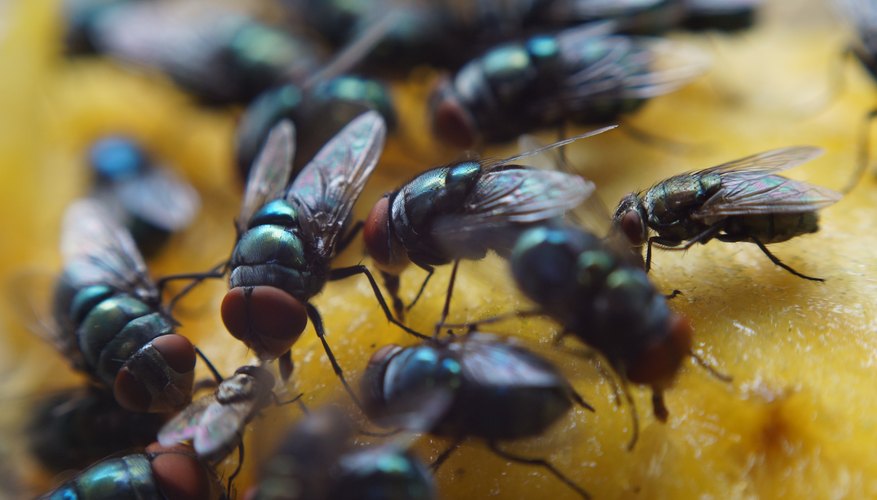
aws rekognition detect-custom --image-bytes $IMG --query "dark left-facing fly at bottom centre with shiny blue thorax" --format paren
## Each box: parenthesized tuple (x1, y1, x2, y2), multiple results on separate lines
(361, 333, 593, 498)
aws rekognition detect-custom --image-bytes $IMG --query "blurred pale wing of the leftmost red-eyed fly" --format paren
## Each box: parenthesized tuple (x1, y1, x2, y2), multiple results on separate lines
(61, 200, 158, 300)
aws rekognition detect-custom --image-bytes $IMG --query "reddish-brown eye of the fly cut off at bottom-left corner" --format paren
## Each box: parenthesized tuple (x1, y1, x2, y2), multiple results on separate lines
(146, 443, 212, 500)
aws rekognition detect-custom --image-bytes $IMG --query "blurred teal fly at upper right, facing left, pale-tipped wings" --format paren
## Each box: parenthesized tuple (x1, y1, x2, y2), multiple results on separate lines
(429, 23, 705, 148)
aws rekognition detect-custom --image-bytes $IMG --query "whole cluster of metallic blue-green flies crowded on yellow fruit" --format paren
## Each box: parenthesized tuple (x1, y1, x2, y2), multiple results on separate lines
(35, 0, 873, 499)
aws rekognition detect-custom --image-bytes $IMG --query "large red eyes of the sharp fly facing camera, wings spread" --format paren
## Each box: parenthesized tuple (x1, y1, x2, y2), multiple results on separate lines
(220, 286, 308, 360)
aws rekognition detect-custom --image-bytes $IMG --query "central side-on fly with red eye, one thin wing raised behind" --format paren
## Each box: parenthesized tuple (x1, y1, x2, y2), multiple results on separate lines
(363, 126, 614, 318)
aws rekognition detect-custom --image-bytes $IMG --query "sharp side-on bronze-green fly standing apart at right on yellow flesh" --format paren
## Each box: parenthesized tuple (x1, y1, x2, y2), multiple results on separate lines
(613, 146, 841, 281)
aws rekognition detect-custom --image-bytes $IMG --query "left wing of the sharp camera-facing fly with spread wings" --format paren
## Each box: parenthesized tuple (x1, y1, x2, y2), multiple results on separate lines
(236, 120, 295, 234)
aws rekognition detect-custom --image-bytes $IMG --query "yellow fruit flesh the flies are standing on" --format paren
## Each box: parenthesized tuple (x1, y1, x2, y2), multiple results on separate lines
(0, 1, 877, 498)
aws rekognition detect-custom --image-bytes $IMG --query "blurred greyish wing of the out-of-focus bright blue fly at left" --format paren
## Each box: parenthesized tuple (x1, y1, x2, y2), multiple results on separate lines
(116, 168, 201, 232)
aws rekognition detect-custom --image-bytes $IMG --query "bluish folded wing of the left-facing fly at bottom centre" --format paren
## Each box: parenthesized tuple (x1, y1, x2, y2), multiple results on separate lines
(456, 334, 563, 387)
